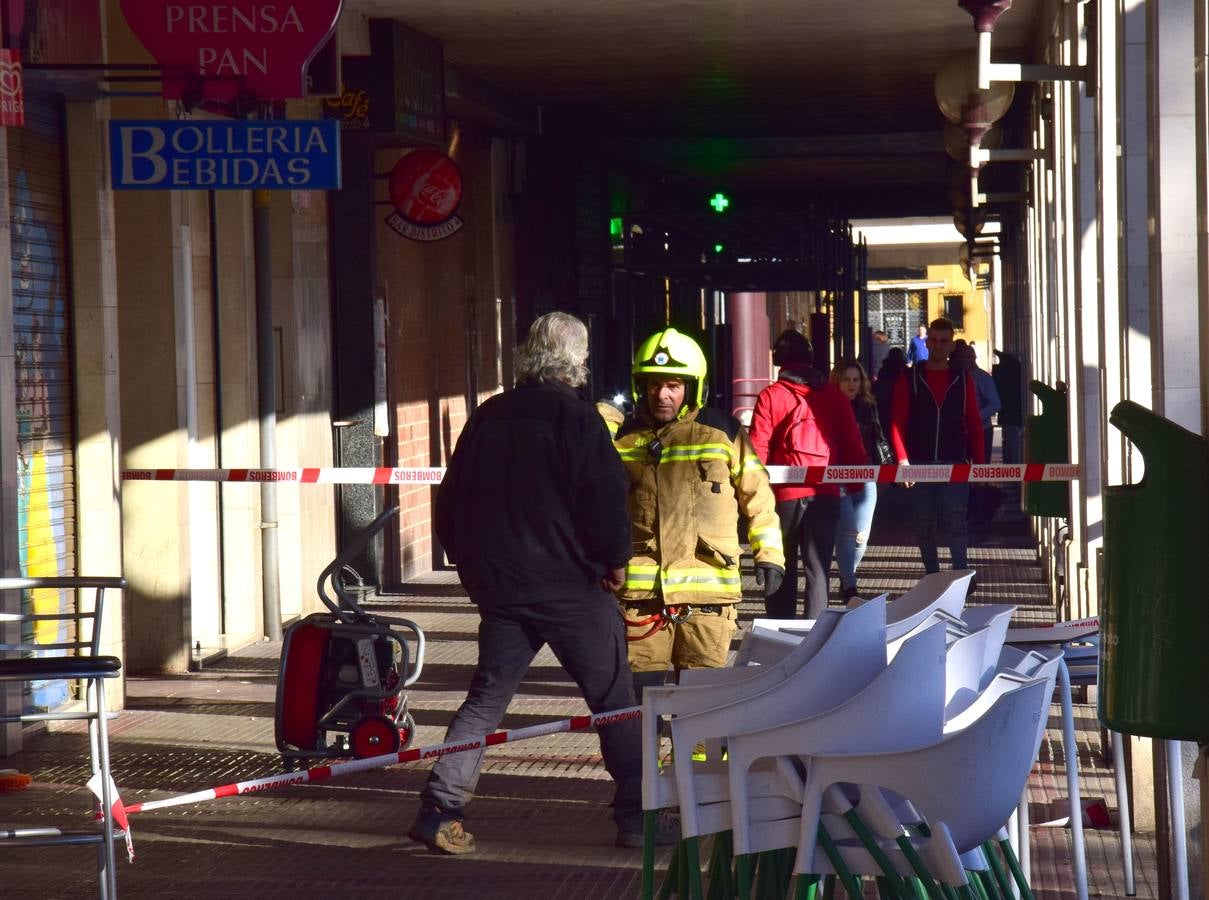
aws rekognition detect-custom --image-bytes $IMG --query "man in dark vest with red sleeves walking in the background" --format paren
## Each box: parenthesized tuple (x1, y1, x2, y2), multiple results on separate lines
(890, 318, 984, 572)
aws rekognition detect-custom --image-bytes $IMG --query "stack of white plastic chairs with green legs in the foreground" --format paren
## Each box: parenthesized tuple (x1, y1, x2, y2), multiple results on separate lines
(643, 570, 1055, 896)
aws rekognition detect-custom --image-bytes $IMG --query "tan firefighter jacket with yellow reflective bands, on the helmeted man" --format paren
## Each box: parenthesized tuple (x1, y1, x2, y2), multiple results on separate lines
(615, 408, 785, 606)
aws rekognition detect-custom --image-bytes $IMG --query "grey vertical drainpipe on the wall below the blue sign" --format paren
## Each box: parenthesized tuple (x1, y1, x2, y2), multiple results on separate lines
(251, 190, 282, 641)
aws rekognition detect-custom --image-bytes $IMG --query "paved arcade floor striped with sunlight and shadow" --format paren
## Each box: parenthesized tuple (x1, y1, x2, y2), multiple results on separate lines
(0, 492, 1157, 900)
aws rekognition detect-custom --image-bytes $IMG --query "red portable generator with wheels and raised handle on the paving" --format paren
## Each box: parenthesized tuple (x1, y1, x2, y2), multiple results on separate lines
(274, 507, 424, 763)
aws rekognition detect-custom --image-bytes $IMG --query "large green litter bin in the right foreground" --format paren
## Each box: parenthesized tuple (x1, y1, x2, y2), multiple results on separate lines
(1100, 400, 1209, 743)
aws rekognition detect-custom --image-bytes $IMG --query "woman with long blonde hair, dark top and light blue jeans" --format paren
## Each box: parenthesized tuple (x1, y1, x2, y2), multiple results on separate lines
(831, 358, 893, 600)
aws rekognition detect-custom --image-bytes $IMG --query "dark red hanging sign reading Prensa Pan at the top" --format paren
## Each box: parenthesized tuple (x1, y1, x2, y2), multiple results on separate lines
(120, 0, 342, 102)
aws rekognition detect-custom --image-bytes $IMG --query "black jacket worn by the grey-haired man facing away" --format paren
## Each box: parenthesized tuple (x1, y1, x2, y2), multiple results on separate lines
(436, 381, 631, 606)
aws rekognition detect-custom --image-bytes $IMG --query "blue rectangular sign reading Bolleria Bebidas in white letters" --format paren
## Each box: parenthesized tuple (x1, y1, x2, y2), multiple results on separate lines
(109, 119, 340, 191)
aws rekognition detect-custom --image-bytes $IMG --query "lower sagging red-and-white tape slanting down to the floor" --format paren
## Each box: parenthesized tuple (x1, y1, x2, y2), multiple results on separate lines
(114, 706, 642, 819)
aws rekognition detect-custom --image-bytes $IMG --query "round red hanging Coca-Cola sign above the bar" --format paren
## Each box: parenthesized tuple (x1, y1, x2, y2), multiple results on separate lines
(386, 148, 465, 241)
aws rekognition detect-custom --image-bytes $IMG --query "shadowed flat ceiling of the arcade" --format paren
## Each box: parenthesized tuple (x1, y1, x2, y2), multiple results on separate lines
(346, 0, 1053, 218)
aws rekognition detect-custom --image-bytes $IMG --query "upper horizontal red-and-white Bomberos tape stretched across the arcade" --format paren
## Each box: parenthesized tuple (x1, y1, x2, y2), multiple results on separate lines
(122, 462, 1081, 484)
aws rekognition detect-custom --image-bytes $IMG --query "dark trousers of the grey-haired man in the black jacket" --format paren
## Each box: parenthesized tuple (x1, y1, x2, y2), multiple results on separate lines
(420, 585, 642, 831)
